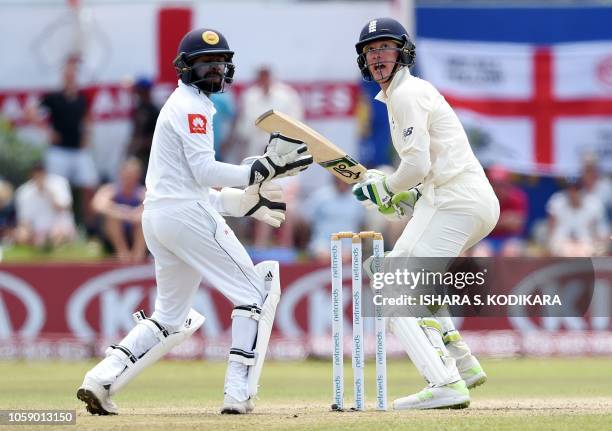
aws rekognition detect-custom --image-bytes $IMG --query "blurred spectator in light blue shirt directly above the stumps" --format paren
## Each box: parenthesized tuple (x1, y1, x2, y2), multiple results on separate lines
(302, 177, 364, 261)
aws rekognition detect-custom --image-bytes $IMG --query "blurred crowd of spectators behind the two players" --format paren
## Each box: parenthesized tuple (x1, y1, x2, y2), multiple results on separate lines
(0, 59, 612, 263)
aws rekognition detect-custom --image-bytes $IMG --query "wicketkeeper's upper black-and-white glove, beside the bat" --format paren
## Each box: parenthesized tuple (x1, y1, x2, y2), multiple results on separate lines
(243, 133, 313, 185)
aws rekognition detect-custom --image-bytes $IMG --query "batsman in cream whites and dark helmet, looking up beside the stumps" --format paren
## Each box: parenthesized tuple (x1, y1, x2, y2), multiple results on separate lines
(353, 18, 499, 409)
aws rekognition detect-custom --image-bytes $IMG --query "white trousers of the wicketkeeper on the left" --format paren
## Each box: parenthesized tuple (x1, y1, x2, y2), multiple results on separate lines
(142, 201, 265, 330)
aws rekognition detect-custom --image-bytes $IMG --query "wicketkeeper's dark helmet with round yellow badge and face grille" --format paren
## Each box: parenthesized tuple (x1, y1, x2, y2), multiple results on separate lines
(173, 28, 236, 93)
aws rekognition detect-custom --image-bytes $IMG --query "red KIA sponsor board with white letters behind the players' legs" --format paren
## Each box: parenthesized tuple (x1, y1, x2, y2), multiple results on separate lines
(0, 258, 612, 360)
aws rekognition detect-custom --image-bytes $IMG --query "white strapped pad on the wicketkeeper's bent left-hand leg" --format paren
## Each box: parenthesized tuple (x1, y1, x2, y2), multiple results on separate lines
(106, 309, 205, 395)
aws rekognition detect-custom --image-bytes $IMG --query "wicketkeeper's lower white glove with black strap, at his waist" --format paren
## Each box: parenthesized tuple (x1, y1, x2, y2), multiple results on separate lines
(221, 182, 287, 227)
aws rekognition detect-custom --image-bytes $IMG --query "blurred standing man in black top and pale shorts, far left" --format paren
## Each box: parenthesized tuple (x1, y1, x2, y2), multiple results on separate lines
(27, 56, 99, 227)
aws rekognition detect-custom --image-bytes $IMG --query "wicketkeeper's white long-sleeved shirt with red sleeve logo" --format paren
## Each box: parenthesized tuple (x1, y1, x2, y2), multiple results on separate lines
(144, 81, 250, 211)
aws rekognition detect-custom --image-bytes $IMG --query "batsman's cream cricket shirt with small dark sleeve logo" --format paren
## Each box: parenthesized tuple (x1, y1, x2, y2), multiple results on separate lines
(376, 67, 488, 200)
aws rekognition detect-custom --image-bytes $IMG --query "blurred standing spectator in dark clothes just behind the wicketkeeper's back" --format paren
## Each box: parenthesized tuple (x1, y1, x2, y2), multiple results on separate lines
(127, 78, 159, 183)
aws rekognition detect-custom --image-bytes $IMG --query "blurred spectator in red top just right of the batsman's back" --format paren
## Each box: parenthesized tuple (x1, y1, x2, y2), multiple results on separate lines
(486, 166, 528, 256)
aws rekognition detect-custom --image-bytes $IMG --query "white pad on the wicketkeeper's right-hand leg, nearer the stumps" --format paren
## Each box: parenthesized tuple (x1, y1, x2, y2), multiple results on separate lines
(247, 260, 281, 397)
